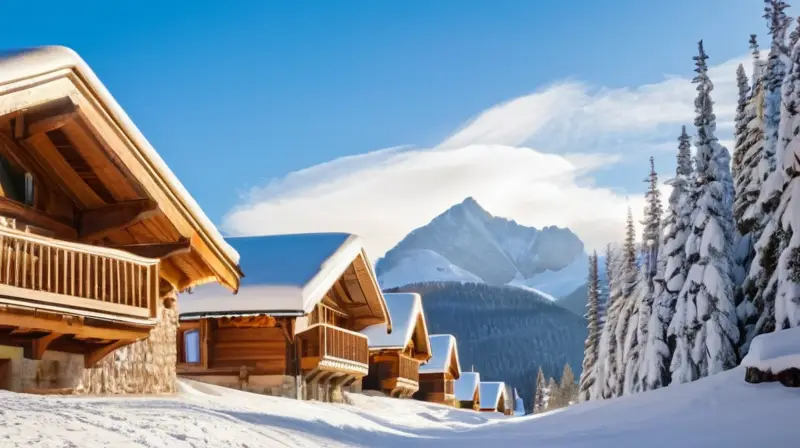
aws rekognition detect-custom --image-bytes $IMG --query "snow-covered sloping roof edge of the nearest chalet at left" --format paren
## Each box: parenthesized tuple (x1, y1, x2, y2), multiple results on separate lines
(0, 46, 239, 280)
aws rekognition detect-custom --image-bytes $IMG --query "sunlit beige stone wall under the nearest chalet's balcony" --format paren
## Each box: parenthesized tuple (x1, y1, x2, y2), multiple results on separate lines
(75, 299, 178, 395)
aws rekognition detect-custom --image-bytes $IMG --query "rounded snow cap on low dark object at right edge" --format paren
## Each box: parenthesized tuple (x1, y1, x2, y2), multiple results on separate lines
(742, 328, 800, 373)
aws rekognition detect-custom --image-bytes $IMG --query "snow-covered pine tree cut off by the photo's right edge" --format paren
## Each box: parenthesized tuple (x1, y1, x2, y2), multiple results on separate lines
(774, 28, 800, 329)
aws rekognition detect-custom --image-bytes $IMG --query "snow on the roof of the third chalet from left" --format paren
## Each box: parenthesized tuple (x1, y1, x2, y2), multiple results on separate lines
(361, 293, 430, 350)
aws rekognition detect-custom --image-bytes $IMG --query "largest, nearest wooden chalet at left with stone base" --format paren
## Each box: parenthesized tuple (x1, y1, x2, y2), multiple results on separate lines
(0, 47, 241, 393)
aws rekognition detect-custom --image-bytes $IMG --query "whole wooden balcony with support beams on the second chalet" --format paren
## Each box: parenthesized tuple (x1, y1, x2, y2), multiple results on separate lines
(297, 324, 369, 378)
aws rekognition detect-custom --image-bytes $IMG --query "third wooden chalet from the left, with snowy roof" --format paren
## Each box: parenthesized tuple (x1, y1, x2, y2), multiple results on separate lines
(361, 293, 431, 398)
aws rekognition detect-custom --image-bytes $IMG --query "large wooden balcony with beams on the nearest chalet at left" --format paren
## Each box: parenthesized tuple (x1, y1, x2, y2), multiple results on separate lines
(0, 227, 159, 365)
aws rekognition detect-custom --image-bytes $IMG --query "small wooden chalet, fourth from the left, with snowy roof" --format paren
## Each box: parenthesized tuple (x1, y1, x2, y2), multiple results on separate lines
(414, 334, 461, 406)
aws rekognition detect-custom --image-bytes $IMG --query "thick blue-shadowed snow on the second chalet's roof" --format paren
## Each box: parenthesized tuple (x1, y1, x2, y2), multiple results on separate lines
(178, 233, 362, 318)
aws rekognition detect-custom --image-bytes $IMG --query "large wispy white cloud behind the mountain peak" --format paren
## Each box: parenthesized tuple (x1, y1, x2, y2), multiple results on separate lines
(223, 52, 747, 258)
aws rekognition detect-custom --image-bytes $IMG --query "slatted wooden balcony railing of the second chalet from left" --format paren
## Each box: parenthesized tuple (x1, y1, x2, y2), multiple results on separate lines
(297, 324, 369, 368)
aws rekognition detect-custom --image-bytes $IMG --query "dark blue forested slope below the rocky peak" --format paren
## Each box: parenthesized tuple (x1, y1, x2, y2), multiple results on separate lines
(389, 283, 586, 412)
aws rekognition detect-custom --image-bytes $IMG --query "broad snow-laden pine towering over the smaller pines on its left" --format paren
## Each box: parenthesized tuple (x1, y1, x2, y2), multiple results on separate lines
(670, 40, 739, 383)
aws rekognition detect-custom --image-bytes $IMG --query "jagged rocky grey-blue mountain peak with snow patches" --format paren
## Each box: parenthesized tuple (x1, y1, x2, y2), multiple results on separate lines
(375, 197, 588, 297)
